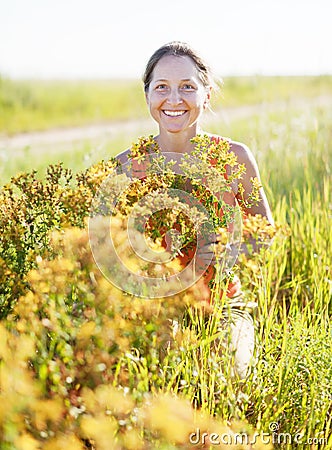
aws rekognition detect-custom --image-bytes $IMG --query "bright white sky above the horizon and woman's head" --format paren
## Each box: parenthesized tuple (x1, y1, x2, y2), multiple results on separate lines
(0, 0, 332, 79)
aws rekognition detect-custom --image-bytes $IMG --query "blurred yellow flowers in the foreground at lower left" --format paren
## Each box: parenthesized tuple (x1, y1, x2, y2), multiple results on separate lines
(0, 222, 272, 450)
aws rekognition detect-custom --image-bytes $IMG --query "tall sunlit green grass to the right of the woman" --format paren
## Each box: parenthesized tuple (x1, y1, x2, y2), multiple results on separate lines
(209, 98, 332, 449)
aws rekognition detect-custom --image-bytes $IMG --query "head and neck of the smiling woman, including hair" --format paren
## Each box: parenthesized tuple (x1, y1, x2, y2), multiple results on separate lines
(143, 42, 214, 152)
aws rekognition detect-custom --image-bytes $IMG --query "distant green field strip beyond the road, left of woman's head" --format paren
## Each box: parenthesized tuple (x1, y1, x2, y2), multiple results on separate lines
(0, 77, 147, 134)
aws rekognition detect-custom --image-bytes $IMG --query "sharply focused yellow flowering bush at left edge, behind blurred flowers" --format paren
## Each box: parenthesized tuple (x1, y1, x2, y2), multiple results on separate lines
(0, 161, 116, 317)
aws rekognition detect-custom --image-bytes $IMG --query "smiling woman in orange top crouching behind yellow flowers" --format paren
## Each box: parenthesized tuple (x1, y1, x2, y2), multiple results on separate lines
(114, 42, 273, 379)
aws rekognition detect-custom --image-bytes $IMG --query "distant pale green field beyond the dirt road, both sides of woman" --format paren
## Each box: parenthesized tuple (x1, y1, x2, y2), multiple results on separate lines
(0, 76, 332, 134)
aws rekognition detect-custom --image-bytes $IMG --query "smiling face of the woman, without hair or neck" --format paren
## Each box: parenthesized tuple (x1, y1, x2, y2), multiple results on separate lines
(146, 56, 210, 134)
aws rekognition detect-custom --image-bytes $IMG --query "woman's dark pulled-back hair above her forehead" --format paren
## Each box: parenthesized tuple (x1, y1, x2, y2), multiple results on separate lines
(143, 41, 214, 92)
